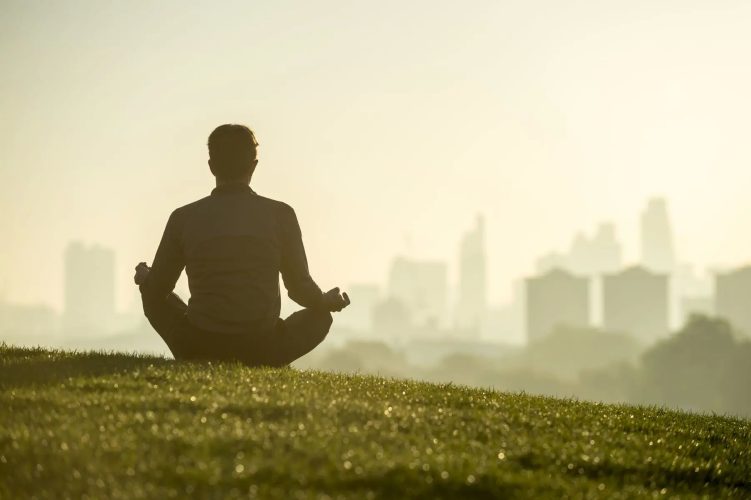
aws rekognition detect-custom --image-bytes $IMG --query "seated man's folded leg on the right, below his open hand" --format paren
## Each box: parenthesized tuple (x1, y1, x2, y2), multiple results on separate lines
(264, 309, 333, 366)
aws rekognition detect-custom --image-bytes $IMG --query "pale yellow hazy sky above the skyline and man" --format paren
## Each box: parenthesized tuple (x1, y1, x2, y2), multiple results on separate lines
(0, 0, 751, 307)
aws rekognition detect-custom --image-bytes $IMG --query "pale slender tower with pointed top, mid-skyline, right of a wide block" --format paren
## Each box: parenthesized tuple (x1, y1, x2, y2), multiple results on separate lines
(455, 216, 488, 335)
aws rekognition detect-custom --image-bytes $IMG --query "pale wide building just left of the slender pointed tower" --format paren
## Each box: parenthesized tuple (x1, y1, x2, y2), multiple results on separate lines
(388, 257, 448, 328)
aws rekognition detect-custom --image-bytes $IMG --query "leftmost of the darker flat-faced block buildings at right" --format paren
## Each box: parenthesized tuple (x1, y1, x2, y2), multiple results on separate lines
(526, 269, 589, 342)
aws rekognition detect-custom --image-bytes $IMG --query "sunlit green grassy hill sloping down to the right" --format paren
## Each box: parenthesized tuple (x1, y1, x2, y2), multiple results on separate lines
(0, 345, 751, 499)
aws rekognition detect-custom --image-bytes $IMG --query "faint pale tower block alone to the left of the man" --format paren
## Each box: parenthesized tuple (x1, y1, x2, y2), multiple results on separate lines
(63, 242, 115, 336)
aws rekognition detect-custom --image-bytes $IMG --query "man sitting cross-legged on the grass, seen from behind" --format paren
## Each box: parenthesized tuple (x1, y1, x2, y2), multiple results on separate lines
(134, 125, 350, 366)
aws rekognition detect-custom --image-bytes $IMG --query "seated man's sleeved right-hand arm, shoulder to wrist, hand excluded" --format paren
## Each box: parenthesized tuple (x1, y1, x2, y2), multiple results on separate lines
(280, 205, 325, 308)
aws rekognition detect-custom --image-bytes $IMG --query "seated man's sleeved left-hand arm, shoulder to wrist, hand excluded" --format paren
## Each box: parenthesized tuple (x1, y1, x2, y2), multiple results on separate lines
(139, 212, 185, 308)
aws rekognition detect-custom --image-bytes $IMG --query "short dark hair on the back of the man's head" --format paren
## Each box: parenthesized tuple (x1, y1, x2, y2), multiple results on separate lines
(209, 124, 258, 179)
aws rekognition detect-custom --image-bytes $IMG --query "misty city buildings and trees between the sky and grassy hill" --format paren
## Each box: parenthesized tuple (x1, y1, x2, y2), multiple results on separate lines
(0, 197, 751, 415)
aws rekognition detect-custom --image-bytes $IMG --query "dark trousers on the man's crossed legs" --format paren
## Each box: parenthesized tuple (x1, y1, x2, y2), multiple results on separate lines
(143, 293, 333, 367)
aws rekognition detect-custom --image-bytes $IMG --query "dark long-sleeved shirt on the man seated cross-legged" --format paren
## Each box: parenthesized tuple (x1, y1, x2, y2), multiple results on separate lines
(141, 184, 323, 334)
